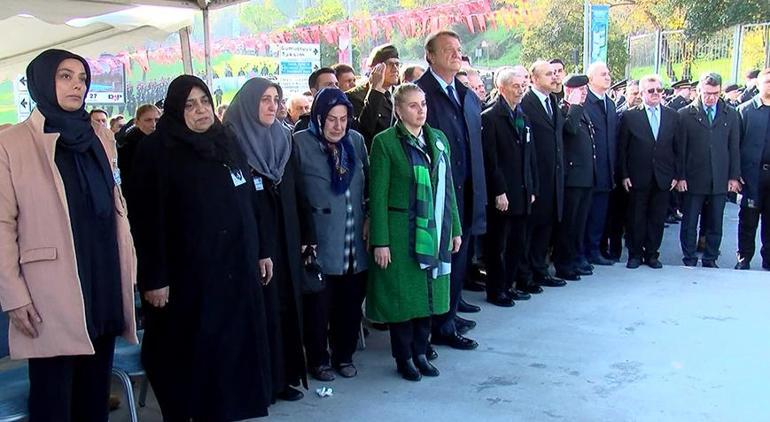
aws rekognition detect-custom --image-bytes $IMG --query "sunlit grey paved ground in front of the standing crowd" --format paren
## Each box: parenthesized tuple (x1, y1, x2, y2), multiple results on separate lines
(7, 206, 770, 422)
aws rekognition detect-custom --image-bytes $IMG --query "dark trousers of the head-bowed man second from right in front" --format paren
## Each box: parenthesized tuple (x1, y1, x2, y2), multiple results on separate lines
(679, 192, 727, 262)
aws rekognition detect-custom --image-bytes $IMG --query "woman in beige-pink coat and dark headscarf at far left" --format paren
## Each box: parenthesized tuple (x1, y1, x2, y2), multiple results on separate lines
(0, 50, 136, 422)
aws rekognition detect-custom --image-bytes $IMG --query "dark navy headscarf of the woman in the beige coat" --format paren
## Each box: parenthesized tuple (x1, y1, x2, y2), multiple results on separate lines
(27, 49, 115, 217)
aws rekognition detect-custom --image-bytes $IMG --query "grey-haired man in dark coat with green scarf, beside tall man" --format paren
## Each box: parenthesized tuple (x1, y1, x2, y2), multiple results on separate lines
(481, 68, 538, 307)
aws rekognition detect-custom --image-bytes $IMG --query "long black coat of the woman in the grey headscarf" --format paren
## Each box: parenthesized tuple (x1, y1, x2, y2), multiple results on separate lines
(252, 152, 316, 393)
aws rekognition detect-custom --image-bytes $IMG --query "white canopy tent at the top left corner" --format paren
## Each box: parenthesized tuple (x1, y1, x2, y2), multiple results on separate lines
(0, 0, 246, 82)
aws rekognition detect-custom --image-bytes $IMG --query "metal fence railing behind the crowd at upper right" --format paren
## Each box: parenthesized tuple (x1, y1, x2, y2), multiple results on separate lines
(626, 22, 770, 83)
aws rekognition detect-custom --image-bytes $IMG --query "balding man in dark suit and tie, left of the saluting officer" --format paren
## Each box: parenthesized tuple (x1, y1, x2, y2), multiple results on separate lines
(521, 61, 566, 293)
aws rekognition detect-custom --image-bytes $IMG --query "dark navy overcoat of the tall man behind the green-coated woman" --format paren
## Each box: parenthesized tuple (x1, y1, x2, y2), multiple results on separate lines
(415, 70, 487, 235)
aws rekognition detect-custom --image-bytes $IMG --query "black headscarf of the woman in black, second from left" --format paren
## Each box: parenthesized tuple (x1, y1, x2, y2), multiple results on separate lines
(153, 75, 236, 170)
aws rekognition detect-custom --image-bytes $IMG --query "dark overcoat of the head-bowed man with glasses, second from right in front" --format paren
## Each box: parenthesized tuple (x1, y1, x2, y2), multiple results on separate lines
(677, 100, 741, 195)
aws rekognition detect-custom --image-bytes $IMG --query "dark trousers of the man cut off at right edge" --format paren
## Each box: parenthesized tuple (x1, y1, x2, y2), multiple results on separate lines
(738, 170, 770, 266)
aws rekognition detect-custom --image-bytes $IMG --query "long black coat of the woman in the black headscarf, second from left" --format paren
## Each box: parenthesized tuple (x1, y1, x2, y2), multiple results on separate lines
(129, 132, 272, 421)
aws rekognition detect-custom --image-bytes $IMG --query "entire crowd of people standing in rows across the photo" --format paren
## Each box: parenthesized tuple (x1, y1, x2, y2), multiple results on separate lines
(0, 30, 770, 421)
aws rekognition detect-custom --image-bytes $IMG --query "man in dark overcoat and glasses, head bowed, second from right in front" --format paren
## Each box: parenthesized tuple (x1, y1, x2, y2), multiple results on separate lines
(677, 73, 741, 268)
